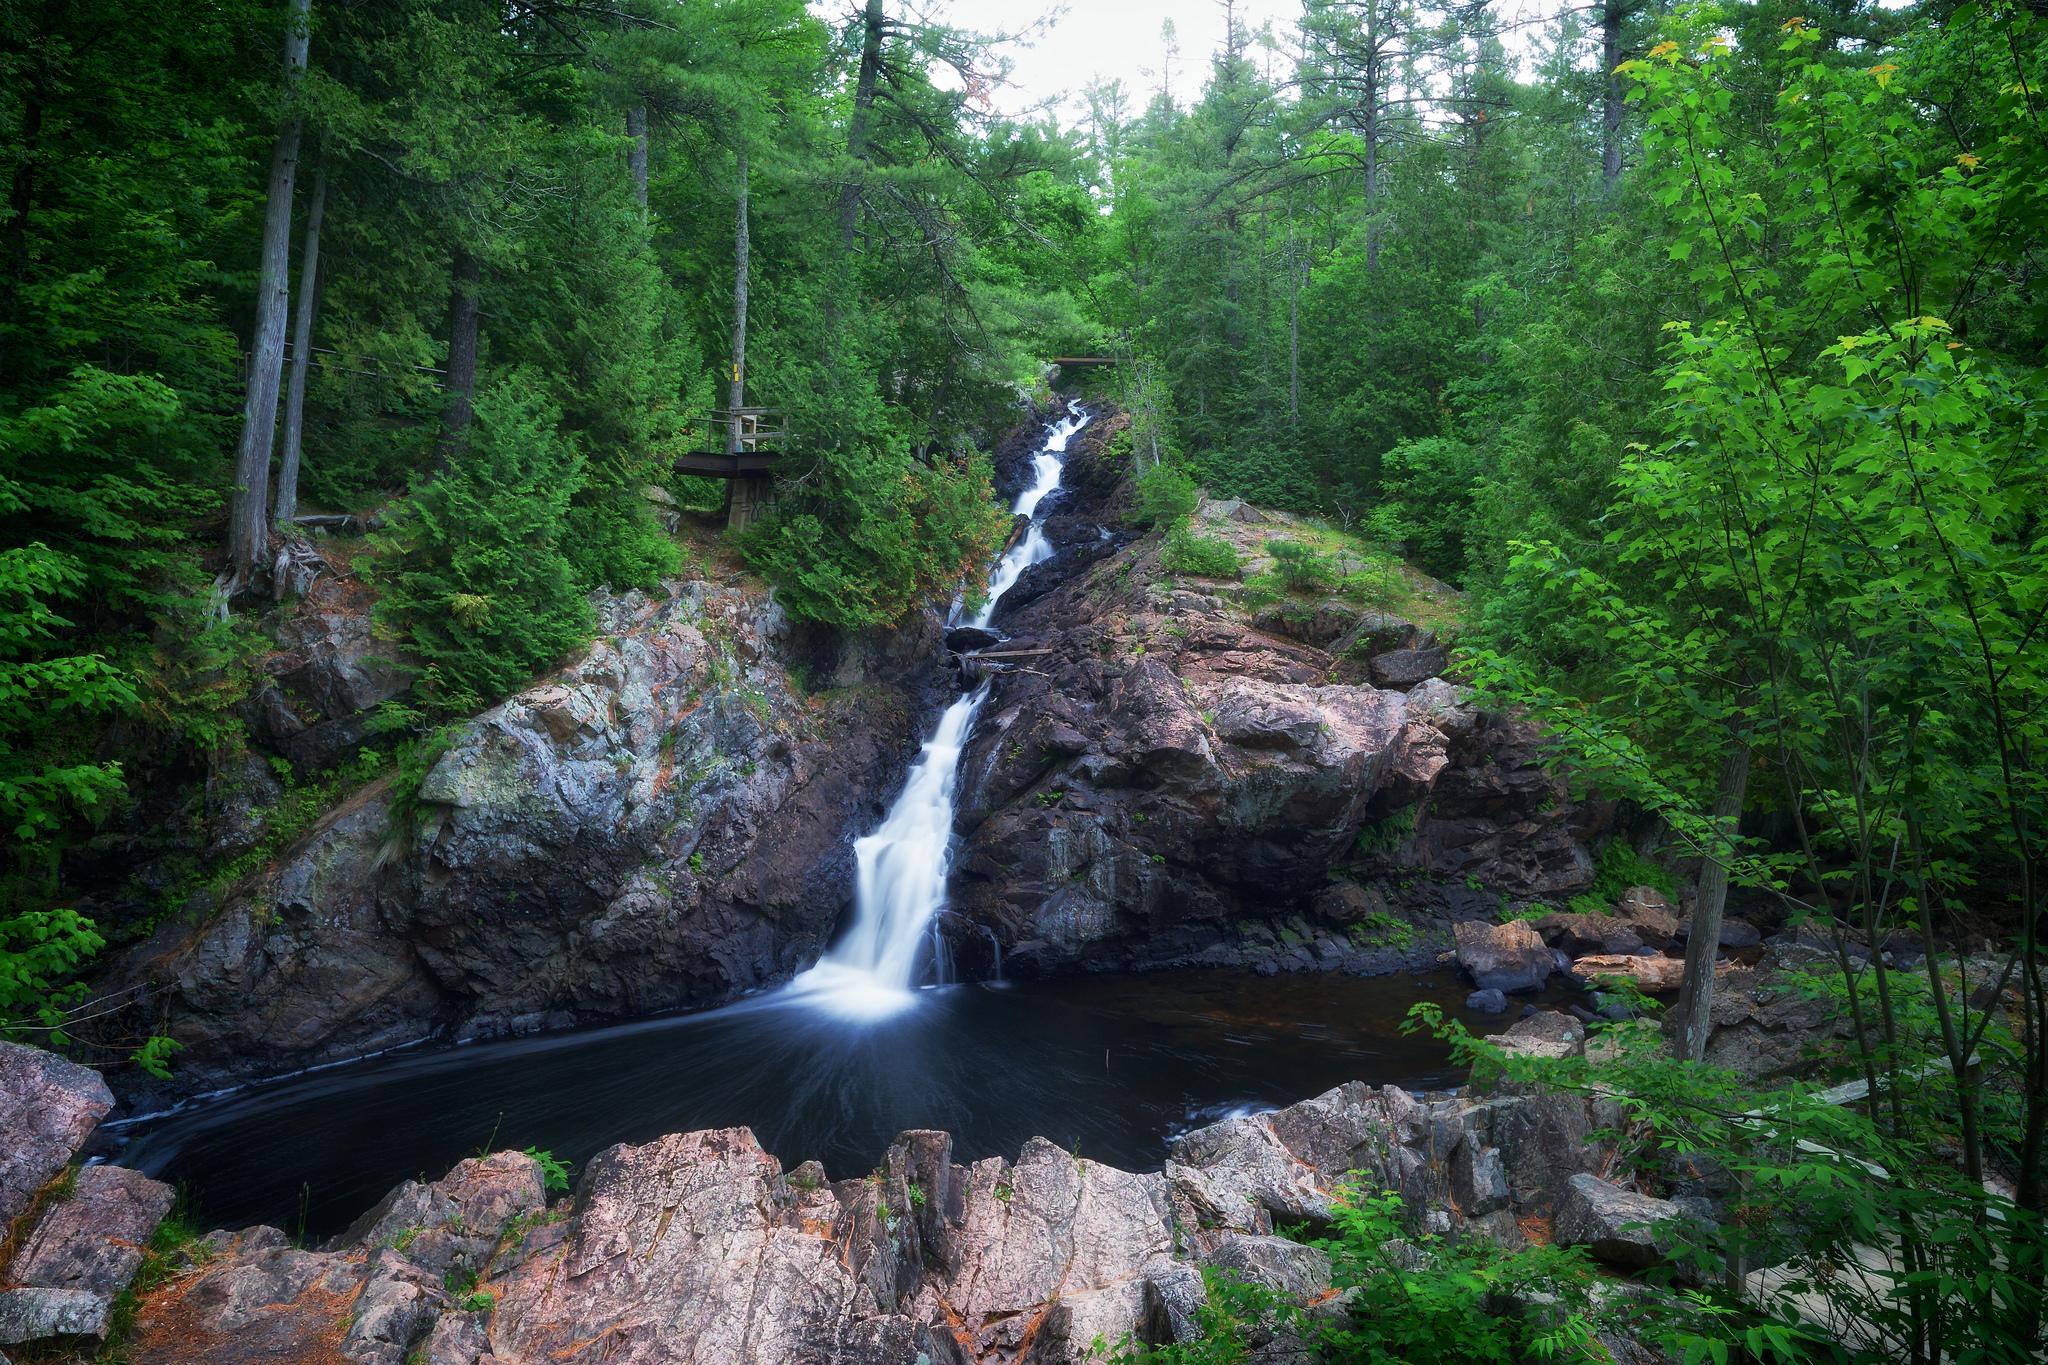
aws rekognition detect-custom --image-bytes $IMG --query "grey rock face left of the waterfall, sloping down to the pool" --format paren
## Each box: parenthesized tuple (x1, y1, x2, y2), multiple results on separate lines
(115, 581, 936, 1087)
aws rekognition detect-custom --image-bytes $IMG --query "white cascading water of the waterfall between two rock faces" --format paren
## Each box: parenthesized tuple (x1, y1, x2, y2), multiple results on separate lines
(791, 403, 1087, 1019)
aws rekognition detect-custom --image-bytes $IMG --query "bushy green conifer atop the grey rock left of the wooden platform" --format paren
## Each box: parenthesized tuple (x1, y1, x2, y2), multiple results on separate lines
(371, 375, 590, 712)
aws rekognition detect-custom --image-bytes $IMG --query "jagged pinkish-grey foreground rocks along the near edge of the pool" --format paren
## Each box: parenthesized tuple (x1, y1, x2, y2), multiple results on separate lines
(0, 1015, 1677, 1365)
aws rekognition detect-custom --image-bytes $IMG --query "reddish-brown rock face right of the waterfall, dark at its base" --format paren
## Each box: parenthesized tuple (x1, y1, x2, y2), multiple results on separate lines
(948, 411, 1602, 972)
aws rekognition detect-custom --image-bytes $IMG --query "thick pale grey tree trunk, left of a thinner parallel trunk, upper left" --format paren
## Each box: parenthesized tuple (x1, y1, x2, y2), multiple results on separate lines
(227, 0, 311, 585)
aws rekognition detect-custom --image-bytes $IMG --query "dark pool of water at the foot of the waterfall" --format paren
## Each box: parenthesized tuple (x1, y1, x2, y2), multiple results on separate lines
(119, 970, 1499, 1236)
